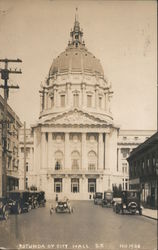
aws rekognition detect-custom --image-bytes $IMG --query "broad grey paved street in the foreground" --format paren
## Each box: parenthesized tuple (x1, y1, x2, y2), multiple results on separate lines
(0, 201, 157, 250)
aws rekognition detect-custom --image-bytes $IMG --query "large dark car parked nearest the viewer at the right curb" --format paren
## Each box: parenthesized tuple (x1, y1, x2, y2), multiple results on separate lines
(114, 190, 142, 215)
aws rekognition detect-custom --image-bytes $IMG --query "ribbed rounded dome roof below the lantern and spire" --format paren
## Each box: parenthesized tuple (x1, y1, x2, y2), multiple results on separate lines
(49, 46, 104, 77)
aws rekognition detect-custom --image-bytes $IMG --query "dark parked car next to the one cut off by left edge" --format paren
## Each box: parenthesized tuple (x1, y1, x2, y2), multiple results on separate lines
(7, 190, 29, 214)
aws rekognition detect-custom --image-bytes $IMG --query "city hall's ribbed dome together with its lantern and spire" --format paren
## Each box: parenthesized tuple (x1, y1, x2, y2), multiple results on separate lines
(49, 13, 104, 78)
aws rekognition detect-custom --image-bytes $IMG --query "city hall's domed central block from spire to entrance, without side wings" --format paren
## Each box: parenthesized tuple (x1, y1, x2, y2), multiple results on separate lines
(32, 16, 118, 200)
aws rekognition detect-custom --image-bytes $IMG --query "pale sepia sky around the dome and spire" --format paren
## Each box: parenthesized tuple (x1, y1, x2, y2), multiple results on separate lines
(0, 0, 157, 130)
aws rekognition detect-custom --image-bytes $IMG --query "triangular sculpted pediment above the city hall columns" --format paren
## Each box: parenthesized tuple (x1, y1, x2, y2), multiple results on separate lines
(43, 109, 109, 126)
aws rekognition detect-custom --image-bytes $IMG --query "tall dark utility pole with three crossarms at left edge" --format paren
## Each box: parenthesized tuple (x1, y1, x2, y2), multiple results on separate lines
(0, 58, 22, 197)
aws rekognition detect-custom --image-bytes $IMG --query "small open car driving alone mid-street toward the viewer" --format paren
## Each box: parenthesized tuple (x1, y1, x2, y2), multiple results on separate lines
(55, 198, 73, 213)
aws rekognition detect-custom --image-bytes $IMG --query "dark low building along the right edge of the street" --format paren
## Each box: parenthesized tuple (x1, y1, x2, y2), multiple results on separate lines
(128, 133, 158, 208)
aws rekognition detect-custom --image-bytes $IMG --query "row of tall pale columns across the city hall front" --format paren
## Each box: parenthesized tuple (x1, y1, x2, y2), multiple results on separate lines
(39, 132, 109, 170)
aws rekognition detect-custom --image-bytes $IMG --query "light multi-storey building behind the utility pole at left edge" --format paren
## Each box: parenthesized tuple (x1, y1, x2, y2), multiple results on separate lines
(0, 95, 22, 196)
